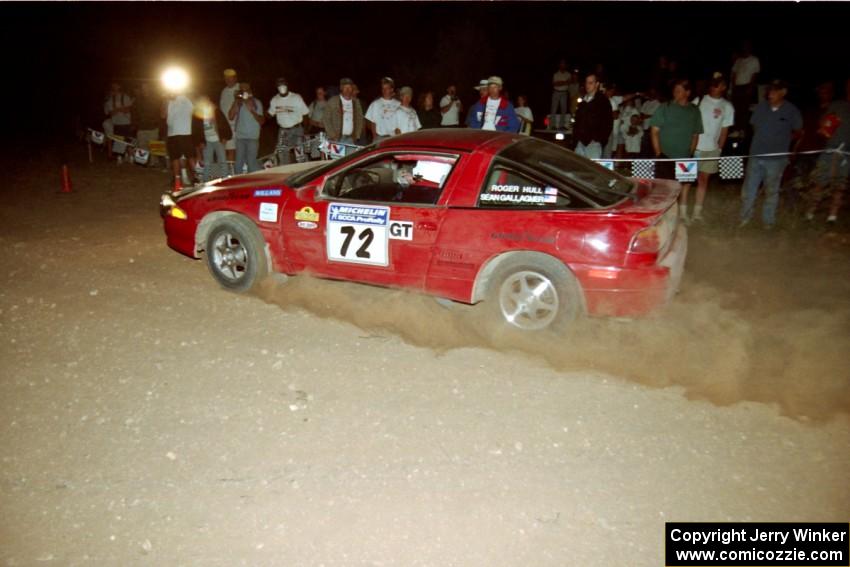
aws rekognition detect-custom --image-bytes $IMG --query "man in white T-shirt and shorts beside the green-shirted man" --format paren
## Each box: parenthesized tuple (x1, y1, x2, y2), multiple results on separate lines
(683, 73, 735, 221)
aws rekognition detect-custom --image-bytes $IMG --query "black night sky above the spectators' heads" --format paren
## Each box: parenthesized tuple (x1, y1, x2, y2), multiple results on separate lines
(0, 2, 850, 146)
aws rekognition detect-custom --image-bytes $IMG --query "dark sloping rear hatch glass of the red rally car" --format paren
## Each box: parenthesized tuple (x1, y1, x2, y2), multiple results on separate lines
(499, 138, 634, 207)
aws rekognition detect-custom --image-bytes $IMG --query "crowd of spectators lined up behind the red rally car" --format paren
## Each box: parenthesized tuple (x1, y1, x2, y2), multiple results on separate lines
(96, 42, 850, 229)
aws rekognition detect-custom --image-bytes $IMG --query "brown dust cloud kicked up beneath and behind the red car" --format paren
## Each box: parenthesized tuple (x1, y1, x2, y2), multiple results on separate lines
(260, 231, 850, 421)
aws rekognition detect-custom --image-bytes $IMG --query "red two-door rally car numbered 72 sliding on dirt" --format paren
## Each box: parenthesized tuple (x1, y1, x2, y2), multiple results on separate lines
(160, 129, 687, 331)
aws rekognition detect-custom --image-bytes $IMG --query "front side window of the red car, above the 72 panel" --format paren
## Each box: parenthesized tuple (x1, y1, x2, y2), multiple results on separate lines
(325, 154, 455, 205)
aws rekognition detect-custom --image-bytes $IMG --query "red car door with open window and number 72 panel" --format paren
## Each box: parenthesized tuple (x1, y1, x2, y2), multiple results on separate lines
(284, 151, 457, 289)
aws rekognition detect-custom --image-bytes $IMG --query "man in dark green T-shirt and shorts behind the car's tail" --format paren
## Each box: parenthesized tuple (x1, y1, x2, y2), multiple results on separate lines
(649, 79, 703, 222)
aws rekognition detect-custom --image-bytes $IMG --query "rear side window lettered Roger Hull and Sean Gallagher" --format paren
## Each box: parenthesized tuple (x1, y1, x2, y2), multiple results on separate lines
(478, 165, 582, 209)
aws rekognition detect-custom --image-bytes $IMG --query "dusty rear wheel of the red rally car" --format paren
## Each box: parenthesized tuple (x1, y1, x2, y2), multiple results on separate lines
(483, 254, 585, 332)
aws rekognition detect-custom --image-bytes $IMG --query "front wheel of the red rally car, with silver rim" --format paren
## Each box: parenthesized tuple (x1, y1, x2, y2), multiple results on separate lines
(205, 215, 269, 292)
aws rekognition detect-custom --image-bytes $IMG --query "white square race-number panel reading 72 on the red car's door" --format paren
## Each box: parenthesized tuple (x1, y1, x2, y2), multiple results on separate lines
(327, 203, 390, 266)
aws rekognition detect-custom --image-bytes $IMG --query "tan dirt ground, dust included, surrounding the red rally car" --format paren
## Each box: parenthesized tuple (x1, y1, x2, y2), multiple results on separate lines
(0, 152, 850, 566)
